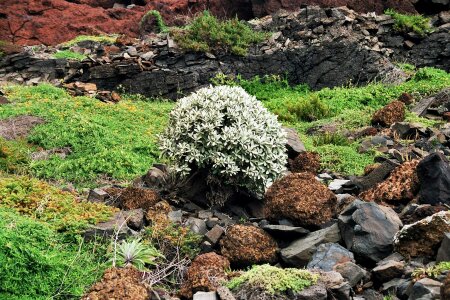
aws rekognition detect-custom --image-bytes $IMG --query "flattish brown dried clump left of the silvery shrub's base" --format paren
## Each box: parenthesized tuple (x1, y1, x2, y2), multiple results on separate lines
(105, 187, 161, 211)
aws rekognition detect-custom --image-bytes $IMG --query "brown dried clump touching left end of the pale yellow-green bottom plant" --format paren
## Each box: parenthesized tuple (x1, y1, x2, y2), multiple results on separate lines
(180, 252, 230, 299)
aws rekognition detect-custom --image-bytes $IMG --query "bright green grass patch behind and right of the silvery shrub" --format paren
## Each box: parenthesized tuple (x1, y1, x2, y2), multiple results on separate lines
(213, 68, 450, 175)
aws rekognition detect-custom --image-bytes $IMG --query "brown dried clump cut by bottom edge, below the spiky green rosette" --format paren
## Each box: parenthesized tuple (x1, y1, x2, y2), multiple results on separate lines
(82, 268, 150, 300)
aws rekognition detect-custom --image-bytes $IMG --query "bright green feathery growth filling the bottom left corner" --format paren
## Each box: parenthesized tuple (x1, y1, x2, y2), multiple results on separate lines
(0, 208, 106, 300)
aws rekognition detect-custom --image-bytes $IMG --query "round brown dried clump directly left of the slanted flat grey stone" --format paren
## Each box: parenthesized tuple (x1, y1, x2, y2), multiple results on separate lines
(220, 225, 278, 266)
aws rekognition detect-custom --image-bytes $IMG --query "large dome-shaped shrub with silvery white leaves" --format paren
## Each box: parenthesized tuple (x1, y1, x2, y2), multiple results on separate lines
(160, 86, 287, 193)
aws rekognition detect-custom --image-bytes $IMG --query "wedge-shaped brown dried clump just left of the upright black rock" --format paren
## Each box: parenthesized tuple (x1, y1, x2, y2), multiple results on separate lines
(359, 160, 419, 203)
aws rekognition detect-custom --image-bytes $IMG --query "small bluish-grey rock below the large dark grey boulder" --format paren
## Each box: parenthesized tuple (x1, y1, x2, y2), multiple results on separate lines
(307, 243, 355, 271)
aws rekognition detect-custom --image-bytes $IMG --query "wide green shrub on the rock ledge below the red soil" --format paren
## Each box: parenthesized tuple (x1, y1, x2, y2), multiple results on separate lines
(171, 11, 267, 55)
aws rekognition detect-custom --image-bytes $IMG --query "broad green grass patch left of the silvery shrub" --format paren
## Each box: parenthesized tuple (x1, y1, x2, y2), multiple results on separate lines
(0, 84, 173, 187)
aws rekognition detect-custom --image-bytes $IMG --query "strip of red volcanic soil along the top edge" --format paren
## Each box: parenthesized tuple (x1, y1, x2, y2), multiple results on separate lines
(0, 0, 415, 45)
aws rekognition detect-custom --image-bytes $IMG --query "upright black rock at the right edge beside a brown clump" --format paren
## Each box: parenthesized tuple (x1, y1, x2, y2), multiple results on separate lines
(417, 152, 450, 205)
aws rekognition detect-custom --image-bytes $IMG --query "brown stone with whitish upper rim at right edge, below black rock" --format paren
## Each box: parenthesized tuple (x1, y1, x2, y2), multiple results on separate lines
(394, 211, 450, 258)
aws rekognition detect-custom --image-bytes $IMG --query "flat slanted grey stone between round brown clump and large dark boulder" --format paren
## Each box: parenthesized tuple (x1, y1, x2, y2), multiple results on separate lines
(281, 224, 341, 267)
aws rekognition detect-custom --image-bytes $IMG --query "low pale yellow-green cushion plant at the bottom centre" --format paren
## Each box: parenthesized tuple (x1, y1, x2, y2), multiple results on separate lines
(227, 264, 319, 294)
